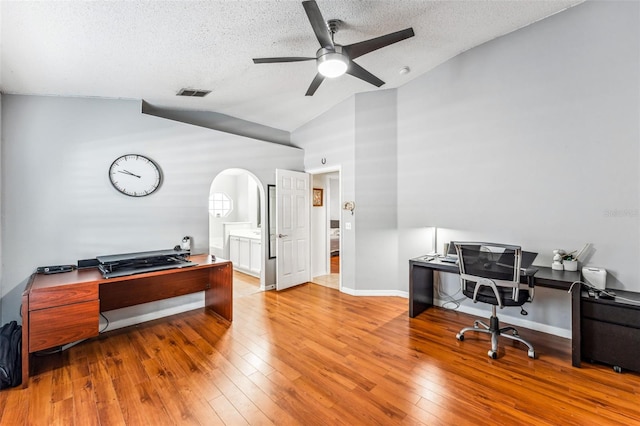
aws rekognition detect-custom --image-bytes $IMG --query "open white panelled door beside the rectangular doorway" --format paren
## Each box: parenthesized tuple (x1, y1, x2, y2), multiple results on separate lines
(276, 169, 311, 290)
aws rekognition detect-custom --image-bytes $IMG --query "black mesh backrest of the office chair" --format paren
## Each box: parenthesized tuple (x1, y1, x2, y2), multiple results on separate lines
(453, 241, 522, 287)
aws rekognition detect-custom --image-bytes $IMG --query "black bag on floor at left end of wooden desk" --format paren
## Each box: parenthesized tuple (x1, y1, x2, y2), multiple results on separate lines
(0, 321, 22, 389)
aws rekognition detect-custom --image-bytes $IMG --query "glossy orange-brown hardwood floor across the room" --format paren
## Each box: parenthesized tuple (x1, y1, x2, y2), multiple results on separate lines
(0, 275, 640, 425)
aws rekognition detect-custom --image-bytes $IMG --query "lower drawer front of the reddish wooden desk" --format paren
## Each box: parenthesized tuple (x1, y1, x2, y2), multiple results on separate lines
(29, 300, 100, 352)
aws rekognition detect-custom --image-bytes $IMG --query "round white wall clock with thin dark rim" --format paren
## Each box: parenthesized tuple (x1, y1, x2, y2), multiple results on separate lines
(109, 154, 162, 197)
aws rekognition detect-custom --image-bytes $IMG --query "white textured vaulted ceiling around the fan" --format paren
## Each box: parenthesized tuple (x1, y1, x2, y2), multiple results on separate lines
(0, 0, 581, 131)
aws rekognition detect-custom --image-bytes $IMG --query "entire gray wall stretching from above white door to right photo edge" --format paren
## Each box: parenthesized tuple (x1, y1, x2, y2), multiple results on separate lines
(292, 2, 640, 336)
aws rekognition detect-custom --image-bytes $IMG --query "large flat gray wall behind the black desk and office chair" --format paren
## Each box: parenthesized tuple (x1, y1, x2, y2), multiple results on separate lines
(398, 1, 640, 330)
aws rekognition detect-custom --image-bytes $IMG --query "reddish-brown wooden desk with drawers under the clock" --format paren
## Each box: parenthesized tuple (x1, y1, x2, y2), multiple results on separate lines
(22, 255, 233, 387)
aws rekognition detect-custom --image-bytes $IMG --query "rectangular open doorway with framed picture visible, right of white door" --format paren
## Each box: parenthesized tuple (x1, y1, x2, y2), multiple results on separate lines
(311, 170, 342, 290)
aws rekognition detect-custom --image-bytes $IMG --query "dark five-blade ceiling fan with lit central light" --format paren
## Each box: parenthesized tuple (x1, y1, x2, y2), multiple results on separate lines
(253, 0, 415, 96)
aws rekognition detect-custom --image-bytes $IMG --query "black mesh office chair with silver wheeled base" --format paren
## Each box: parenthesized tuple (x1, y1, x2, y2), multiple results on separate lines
(453, 241, 536, 359)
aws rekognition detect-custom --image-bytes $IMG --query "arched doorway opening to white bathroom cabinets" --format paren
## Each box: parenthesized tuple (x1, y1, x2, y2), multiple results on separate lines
(209, 169, 267, 289)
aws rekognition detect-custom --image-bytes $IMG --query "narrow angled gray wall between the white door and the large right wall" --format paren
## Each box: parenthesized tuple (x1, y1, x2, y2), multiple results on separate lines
(291, 90, 399, 295)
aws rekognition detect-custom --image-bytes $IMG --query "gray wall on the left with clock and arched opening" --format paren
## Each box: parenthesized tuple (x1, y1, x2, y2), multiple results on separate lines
(1, 95, 303, 321)
